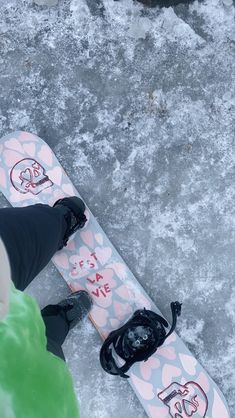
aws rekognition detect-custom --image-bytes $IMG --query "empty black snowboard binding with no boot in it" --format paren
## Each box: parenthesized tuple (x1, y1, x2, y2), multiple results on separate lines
(100, 302, 181, 378)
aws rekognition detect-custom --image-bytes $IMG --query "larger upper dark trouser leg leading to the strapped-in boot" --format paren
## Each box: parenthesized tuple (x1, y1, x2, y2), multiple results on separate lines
(0, 204, 67, 290)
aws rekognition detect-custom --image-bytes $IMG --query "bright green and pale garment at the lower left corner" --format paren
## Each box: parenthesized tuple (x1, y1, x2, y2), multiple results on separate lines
(0, 288, 79, 418)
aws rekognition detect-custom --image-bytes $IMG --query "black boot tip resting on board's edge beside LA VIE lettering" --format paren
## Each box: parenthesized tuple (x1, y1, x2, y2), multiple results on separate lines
(58, 290, 93, 329)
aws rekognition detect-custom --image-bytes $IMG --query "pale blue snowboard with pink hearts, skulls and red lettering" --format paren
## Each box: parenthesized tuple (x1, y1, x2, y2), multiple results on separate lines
(0, 131, 230, 418)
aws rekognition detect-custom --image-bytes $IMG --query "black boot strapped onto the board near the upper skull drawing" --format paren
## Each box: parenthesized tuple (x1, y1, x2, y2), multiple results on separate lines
(53, 196, 87, 250)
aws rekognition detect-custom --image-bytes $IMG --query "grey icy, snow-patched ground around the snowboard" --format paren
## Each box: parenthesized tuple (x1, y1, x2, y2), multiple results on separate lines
(0, 0, 235, 418)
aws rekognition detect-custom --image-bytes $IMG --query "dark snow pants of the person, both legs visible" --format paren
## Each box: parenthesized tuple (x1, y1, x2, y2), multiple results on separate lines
(0, 204, 69, 360)
